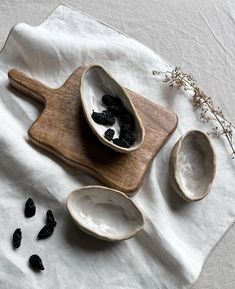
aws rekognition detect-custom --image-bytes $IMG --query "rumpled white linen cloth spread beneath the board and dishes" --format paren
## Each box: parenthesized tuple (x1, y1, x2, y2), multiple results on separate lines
(0, 5, 235, 289)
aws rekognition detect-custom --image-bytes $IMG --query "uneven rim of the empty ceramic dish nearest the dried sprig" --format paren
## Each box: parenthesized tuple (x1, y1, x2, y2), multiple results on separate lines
(170, 129, 216, 202)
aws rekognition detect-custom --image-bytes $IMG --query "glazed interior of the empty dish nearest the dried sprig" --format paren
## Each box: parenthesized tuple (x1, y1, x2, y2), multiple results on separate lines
(176, 132, 214, 199)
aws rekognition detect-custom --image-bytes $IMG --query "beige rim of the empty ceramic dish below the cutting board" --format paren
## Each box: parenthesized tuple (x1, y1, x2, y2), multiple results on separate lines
(66, 185, 145, 242)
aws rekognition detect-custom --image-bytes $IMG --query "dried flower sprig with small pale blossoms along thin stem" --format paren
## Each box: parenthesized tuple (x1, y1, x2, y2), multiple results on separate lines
(153, 67, 235, 159)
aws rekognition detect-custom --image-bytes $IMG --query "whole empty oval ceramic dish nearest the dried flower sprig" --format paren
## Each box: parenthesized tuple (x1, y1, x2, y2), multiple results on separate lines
(169, 130, 216, 202)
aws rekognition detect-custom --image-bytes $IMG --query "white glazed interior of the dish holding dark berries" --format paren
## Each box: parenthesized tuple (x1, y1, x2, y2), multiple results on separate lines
(82, 66, 143, 149)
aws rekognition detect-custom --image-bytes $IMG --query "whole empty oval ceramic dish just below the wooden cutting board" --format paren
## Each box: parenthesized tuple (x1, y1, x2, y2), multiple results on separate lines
(67, 186, 144, 241)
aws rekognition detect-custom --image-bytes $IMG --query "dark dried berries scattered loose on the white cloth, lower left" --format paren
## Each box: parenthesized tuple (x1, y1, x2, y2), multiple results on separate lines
(12, 198, 56, 271)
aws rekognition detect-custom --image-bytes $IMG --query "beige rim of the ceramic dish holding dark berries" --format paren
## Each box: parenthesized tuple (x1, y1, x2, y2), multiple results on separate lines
(79, 64, 145, 153)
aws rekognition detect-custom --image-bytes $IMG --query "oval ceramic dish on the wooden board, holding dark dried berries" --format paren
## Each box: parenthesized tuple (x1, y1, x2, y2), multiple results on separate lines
(80, 65, 145, 153)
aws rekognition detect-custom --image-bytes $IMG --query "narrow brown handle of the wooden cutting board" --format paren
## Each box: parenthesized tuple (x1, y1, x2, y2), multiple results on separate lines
(8, 68, 52, 104)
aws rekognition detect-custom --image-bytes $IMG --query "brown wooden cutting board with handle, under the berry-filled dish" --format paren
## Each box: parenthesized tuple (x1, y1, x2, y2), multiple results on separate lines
(8, 66, 177, 194)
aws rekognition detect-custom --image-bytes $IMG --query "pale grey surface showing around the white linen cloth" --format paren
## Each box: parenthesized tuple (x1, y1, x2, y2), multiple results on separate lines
(0, 0, 235, 289)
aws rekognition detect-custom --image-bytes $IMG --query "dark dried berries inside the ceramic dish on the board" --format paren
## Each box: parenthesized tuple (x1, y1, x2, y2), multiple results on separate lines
(91, 95, 137, 148)
